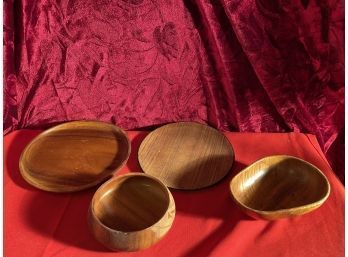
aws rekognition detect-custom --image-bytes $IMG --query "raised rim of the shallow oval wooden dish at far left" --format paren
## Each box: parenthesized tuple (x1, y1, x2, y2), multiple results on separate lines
(19, 120, 132, 193)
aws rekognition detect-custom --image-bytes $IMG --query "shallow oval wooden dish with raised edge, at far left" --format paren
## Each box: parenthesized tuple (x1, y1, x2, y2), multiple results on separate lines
(19, 121, 131, 192)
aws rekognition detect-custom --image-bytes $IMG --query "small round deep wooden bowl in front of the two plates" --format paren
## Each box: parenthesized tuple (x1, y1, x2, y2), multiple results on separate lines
(88, 173, 175, 251)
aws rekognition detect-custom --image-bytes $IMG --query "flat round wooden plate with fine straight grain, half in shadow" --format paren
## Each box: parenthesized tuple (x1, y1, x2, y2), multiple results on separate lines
(138, 122, 234, 189)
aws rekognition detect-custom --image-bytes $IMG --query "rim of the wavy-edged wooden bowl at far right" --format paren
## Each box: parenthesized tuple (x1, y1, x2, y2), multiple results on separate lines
(230, 154, 331, 216)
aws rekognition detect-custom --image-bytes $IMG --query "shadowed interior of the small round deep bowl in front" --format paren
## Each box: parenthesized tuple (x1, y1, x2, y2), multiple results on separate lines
(92, 175, 170, 232)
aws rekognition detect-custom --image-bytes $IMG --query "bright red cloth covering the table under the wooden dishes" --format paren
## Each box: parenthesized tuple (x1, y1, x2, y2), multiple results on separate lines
(4, 130, 344, 257)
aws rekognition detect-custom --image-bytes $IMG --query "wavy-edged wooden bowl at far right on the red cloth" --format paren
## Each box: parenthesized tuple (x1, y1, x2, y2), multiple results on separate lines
(230, 155, 330, 220)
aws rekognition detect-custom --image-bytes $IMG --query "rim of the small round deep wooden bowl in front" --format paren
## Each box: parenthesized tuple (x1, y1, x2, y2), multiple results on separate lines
(89, 172, 175, 234)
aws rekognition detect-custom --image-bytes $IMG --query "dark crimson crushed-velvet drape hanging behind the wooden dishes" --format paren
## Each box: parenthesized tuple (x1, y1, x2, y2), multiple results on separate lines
(4, 0, 344, 179)
